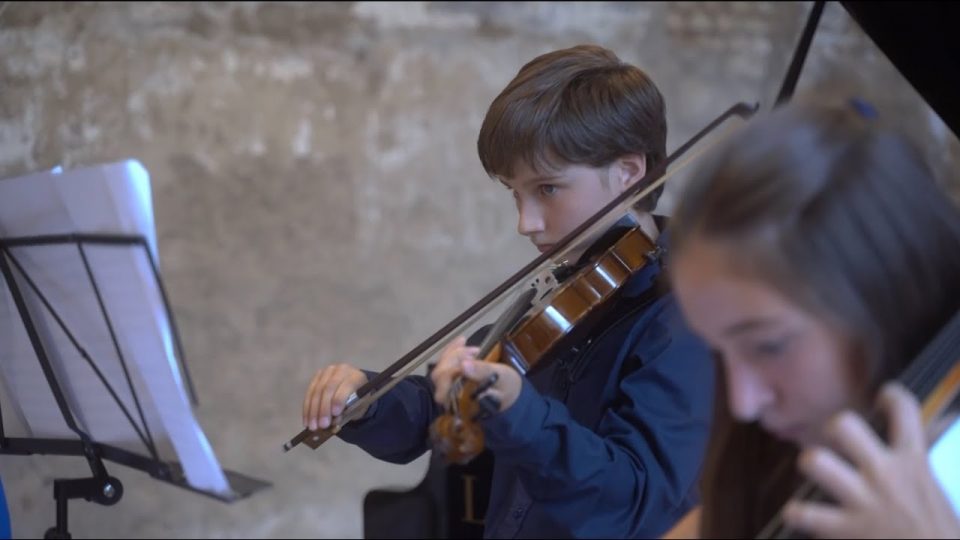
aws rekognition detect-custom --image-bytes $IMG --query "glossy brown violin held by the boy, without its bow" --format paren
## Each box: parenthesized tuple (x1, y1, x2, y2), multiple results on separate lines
(430, 227, 662, 465)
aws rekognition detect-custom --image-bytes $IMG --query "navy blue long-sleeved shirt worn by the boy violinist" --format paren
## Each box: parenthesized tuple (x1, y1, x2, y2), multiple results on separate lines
(339, 226, 714, 538)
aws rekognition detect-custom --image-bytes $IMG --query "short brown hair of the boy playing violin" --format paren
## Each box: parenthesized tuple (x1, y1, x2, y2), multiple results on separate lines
(477, 45, 667, 211)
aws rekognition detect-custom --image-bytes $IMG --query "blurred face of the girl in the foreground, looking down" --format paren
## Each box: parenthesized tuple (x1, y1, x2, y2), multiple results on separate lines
(672, 238, 865, 445)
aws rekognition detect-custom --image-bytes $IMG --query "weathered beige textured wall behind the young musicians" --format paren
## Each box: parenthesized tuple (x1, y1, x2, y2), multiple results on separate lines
(0, 2, 960, 537)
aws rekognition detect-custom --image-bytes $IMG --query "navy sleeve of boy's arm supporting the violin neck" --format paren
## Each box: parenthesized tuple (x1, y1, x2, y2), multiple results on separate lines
(484, 296, 714, 538)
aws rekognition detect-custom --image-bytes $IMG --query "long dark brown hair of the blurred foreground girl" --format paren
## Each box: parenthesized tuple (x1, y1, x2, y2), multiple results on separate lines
(671, 100, 960, 536)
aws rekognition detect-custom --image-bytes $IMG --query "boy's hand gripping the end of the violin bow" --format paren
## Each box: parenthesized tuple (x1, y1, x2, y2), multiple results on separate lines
(303, 364, 367, 430)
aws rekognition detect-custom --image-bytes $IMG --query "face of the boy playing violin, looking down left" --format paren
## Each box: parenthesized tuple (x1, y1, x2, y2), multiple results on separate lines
(500, 157, 646, 261)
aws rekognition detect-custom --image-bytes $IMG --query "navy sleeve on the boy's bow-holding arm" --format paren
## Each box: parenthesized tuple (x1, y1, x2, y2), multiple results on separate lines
(337, 372, 440, 464)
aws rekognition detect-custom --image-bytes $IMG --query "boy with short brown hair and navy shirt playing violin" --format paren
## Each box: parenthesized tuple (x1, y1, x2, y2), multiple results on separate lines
(303, 46, 714, 538)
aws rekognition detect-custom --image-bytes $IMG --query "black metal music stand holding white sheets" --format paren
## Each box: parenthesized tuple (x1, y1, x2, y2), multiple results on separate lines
(0, 225, 271, 538)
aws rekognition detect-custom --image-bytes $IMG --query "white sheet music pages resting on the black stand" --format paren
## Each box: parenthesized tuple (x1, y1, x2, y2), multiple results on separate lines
(0, 160, 231, 493)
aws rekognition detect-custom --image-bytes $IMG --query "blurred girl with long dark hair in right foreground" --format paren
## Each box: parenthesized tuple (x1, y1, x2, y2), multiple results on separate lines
(671, 101, 960, 538)
